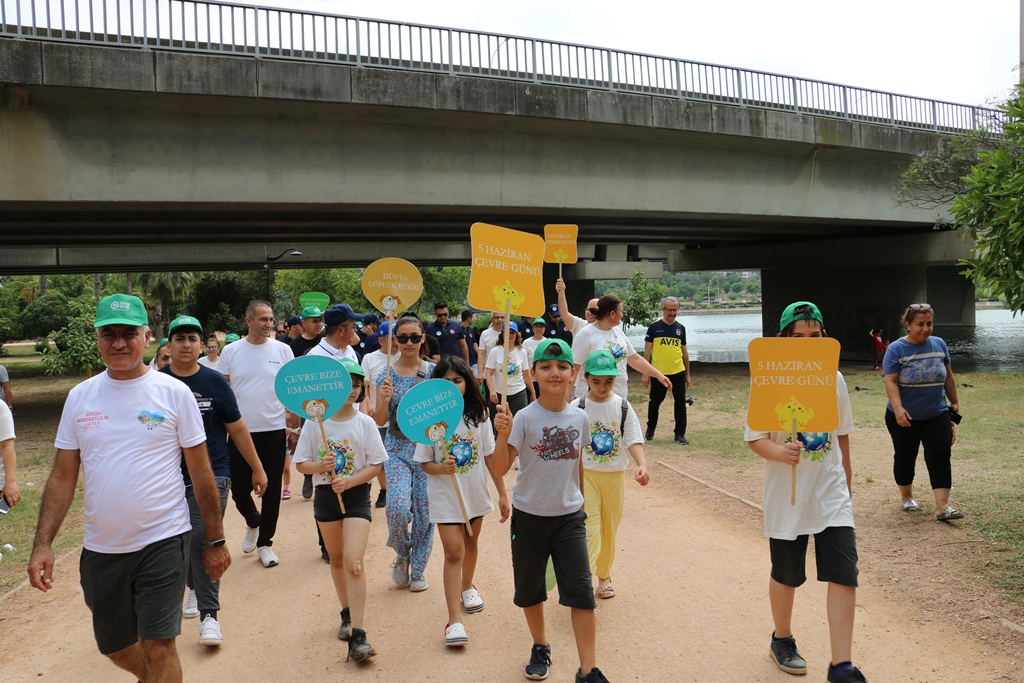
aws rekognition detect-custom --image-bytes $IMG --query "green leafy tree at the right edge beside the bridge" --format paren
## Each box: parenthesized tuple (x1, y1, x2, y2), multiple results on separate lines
(898, 86, 1024, 314)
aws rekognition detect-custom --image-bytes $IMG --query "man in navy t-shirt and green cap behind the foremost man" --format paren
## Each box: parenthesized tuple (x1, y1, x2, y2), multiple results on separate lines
(160, 315, 266, 646)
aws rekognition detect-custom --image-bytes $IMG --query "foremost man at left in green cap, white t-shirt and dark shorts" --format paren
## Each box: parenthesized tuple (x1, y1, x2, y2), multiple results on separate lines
(29, 294, 231, 681)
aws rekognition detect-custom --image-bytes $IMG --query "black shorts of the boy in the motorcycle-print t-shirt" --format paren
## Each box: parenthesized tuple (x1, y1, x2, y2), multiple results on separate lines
(509, 508, 597, 609)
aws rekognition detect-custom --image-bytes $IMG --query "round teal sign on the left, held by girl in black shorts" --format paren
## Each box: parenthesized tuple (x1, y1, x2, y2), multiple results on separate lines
(273, 355, 354, 420)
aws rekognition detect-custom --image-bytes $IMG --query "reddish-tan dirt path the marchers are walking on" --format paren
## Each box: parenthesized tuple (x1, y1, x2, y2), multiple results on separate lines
(0, 464, 1024, 683)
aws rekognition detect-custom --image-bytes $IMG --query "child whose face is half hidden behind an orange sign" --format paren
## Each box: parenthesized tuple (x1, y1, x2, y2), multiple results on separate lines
(743, 301, 866, 683)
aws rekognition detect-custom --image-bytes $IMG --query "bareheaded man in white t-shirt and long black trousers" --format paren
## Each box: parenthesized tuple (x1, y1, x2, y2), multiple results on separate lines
(217, 301, 297, 567)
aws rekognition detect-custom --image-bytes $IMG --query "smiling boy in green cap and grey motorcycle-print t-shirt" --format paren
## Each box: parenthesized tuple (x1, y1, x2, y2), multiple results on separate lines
(492, 339, 607, 683)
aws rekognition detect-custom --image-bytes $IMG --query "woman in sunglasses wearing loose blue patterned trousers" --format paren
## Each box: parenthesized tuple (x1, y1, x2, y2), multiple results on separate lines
(374, 315, 434, 593)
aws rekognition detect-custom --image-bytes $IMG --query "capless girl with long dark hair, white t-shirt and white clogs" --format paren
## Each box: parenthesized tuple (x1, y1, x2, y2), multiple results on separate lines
(414, 356, 511, 647)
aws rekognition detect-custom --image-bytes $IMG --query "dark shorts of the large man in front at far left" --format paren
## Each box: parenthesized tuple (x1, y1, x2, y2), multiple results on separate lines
(79, 531, 189, 654)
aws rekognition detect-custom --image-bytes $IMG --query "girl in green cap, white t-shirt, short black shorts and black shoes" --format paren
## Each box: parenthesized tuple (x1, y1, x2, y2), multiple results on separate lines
(292, 358, 387, 661)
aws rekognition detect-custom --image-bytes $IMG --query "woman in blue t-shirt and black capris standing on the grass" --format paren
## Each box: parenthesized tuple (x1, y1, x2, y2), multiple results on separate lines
(882, 303, 964, 521)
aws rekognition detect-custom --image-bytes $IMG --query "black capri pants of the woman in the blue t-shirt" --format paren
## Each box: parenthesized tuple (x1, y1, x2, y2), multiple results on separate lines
(886, 410, 953, 488)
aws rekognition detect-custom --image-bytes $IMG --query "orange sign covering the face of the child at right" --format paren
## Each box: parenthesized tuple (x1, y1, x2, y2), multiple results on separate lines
(746, 337, 840, 432)
